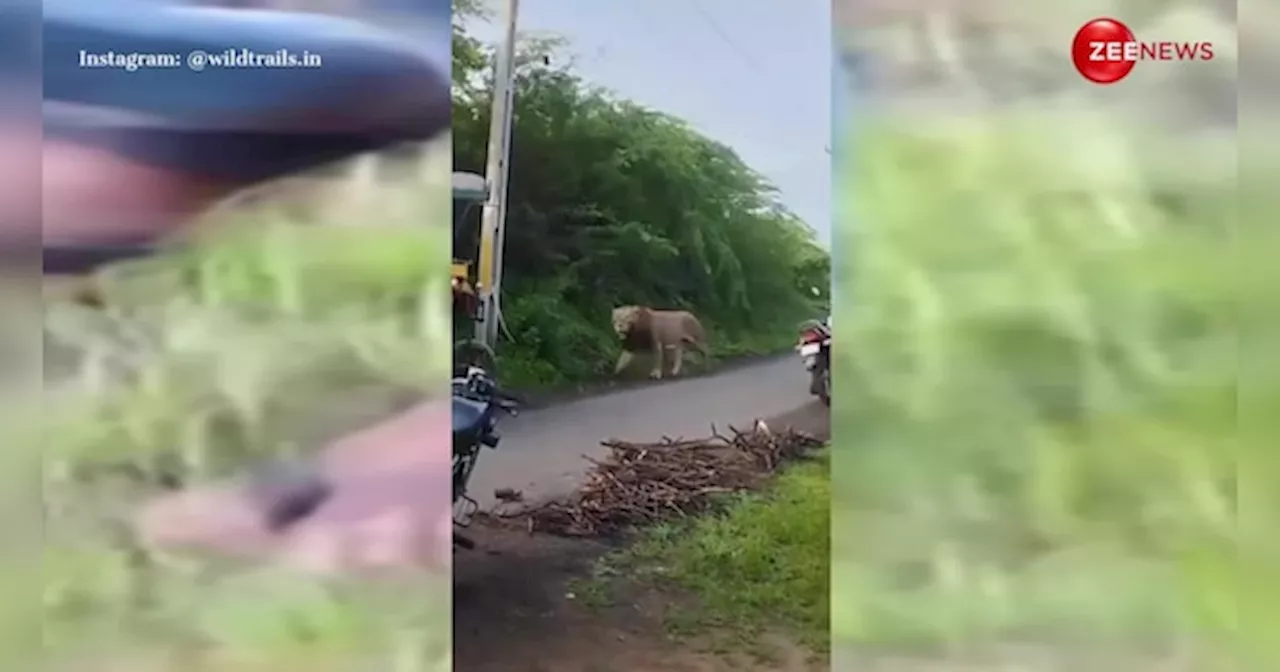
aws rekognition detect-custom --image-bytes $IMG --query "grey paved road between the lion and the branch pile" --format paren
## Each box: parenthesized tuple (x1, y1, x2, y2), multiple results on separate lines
(470, 356, 813, 508)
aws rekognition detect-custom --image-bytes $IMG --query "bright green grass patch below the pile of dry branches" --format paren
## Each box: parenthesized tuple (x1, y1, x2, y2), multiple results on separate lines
(589, 453, 831, 650)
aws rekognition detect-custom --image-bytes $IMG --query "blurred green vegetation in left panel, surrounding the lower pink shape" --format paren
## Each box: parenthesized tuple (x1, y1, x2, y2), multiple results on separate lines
(38, 138, 451, 672)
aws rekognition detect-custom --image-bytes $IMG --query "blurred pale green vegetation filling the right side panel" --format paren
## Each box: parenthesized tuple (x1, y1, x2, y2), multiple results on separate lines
(831, 5, 1239, 669)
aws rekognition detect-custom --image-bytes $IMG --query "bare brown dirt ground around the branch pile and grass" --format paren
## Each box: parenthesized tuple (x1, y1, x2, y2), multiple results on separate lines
(453, 403, 829, 672)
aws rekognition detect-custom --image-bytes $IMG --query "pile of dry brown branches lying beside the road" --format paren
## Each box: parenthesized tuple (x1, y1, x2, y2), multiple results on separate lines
(488, 422, 822, 536)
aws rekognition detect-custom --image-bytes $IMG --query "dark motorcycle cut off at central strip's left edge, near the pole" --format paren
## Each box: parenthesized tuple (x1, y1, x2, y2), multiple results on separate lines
(452, 366, 520, 549)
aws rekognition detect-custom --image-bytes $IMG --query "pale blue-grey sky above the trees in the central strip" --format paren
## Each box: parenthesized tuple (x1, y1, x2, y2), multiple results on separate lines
(472, 0, 832, 247)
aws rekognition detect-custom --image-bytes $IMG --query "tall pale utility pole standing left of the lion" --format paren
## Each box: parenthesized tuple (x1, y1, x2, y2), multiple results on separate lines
(476, 0, 520, 347)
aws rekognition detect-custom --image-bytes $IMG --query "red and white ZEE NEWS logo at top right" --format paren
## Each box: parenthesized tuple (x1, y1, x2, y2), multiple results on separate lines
(1071, 18, 1213, 84)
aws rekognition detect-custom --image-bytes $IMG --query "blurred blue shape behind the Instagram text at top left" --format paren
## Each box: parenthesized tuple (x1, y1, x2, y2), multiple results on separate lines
(44, 0, 451, 183)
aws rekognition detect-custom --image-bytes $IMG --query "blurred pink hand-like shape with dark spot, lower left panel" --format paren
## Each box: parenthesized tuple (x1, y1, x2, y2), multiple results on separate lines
(138, 402, 453, 575)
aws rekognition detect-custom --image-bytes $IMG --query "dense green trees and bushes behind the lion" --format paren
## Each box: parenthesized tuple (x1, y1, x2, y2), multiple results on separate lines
(453, 8, 829, 385)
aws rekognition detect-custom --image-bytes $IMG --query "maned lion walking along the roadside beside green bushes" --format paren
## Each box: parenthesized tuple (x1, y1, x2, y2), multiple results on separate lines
(613, 306, 710, 379)
